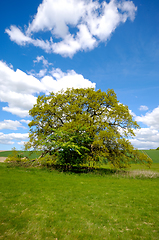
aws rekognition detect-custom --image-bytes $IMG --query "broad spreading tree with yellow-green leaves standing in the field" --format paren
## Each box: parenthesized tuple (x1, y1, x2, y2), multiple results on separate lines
(26, 88, 151, 168)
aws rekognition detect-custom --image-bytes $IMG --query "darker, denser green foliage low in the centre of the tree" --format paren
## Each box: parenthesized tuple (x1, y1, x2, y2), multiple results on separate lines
(41, 125, 90, 165)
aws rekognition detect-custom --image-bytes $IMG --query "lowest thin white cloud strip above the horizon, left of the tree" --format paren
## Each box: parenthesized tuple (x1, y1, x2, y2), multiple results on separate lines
(0, 132, 29, 145)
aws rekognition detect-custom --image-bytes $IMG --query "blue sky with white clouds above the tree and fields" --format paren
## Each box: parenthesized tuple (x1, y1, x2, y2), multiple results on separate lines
(0, 0, 159, 150)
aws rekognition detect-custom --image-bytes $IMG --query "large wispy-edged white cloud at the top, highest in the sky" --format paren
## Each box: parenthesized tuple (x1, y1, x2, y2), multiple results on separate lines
(6, 0, 137, 57)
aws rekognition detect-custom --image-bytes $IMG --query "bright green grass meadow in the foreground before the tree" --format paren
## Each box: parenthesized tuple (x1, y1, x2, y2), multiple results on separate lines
(0, 163, 159, 240)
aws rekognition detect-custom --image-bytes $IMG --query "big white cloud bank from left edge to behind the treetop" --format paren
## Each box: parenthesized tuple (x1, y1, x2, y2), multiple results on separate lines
(0, 59, 95, 118)
